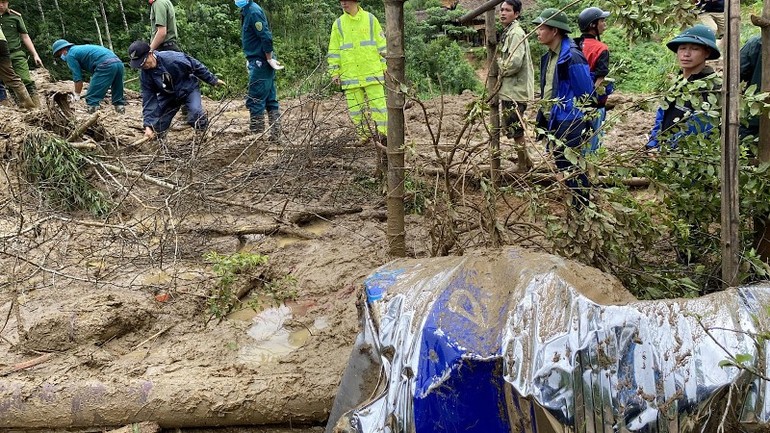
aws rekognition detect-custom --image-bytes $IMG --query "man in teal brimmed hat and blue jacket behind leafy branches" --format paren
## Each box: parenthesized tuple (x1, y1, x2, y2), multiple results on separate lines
(647, 24, 720, 149)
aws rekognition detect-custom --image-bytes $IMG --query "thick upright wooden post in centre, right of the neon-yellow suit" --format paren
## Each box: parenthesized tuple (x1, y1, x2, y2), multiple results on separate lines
(385, 0, 406, 257)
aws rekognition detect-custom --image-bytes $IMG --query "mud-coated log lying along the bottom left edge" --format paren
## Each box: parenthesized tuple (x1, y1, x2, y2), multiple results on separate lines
(0, 371, 331, 429)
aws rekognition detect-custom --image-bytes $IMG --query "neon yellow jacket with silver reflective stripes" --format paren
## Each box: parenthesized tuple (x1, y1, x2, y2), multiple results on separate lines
(326, 6, 387, 89)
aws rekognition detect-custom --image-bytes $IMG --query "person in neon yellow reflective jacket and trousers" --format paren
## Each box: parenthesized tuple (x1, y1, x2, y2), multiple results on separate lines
(327, 0, 388, 142)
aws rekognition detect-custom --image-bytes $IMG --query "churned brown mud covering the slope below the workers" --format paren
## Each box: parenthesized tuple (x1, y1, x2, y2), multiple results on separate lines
(0, 71, 652, 433)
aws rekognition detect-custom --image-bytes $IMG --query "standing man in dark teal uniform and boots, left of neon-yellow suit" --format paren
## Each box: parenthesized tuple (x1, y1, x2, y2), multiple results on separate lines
(235, 0, 283, 142)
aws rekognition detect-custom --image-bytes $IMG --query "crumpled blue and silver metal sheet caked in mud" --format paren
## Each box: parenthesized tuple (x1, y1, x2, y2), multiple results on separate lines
(327, 249, 770, 433)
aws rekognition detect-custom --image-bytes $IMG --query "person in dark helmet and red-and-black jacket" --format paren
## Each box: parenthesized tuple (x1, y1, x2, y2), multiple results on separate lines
(575, 7, 614, 155)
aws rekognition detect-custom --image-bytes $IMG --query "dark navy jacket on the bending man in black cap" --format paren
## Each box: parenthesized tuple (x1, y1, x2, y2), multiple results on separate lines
(139, 51, 217, 127)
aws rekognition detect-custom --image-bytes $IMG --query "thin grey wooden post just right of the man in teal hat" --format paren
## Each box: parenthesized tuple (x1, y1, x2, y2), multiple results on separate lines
(720, 0, 741, 288)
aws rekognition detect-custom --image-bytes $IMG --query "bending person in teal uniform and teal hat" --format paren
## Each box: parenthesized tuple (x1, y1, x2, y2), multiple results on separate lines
(51, 39, 126, 113)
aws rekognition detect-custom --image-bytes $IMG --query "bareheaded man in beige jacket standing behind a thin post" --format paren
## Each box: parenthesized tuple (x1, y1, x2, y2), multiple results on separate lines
(497, 0, 535, 170)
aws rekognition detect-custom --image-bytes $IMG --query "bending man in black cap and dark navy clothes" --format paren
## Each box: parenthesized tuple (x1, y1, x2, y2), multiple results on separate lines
(128, 41, 225, 138)
